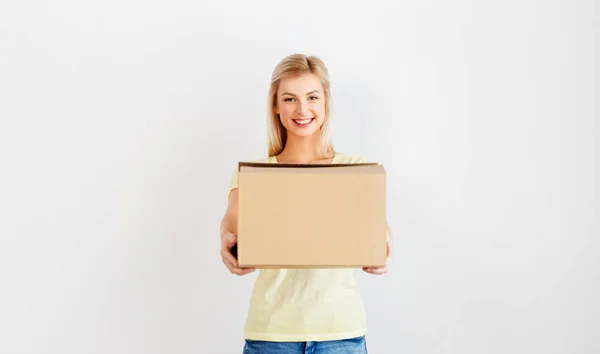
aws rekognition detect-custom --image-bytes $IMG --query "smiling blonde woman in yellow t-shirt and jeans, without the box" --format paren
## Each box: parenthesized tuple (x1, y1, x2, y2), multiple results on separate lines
(221, 54, 391, 354)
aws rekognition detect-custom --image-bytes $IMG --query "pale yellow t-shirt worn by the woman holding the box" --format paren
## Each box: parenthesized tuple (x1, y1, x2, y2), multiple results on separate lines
(230, 153, 367, 342)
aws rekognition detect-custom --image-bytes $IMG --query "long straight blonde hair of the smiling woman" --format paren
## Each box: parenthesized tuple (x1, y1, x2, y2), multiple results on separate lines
(268, 54, 335, 157)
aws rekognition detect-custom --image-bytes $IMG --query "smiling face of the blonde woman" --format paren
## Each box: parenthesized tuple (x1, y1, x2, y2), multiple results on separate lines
(274, 74, 325, 136)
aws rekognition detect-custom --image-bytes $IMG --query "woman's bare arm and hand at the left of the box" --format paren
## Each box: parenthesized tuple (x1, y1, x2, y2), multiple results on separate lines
(221, 188, 255, 275)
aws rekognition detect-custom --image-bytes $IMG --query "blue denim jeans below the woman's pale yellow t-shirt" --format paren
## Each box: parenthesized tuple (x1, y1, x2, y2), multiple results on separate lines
(243, 336, 367, 354)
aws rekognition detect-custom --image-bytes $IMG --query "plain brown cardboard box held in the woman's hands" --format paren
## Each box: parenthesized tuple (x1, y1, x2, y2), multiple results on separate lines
(237, 162, 386, 268)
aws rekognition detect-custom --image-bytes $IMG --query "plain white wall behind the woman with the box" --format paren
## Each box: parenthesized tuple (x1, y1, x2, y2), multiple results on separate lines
(0, 0, 600, 354)
